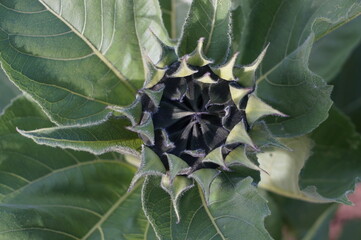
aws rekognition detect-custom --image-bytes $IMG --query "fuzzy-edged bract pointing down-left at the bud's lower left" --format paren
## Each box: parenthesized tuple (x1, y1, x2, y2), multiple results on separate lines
(128, 145, 166, 191)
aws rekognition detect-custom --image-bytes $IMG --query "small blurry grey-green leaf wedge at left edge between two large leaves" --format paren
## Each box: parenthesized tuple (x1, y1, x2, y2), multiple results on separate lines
(0, 68, 20, 112)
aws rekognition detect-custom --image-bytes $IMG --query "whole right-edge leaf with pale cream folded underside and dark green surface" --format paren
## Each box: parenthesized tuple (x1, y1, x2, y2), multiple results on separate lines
(258, 108, 361, 204)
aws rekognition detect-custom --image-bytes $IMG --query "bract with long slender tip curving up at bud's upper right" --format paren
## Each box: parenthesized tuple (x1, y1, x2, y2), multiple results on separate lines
(235, 44, 269, 87)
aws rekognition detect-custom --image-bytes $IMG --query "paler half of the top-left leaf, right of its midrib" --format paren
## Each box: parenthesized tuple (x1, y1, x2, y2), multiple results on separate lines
(40, 0, 172, 63)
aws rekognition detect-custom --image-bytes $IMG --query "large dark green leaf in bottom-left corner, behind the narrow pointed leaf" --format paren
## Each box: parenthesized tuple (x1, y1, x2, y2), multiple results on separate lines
(0, 98, 155, 240)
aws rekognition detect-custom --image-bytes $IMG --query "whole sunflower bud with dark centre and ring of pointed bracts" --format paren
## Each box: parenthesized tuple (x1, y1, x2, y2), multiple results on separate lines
(116, 39, 285, 221)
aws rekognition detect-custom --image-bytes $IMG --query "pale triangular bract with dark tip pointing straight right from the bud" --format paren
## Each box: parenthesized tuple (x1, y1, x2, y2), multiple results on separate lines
(246, 94, 287, 125)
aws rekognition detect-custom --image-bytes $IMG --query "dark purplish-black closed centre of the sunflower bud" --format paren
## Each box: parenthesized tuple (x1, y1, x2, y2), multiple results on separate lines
(145, 62, 247, 170)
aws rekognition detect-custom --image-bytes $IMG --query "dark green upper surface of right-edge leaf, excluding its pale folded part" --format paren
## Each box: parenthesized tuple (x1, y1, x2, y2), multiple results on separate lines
(300, 108, 361, 204)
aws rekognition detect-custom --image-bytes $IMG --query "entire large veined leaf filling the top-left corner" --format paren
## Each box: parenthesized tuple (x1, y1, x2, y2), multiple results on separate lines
(0, 0, 166, 124)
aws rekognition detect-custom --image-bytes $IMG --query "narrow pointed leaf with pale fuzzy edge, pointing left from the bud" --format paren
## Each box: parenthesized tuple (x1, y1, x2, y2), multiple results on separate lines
(18, 117, 142, 156)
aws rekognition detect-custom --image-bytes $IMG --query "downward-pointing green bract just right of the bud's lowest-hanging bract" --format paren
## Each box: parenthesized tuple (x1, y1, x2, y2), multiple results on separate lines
(189, 168, 220, 204)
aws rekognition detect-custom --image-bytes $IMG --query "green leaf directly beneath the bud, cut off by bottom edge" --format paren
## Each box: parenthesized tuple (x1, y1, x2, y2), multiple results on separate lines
(142, 175, 272, 240)
